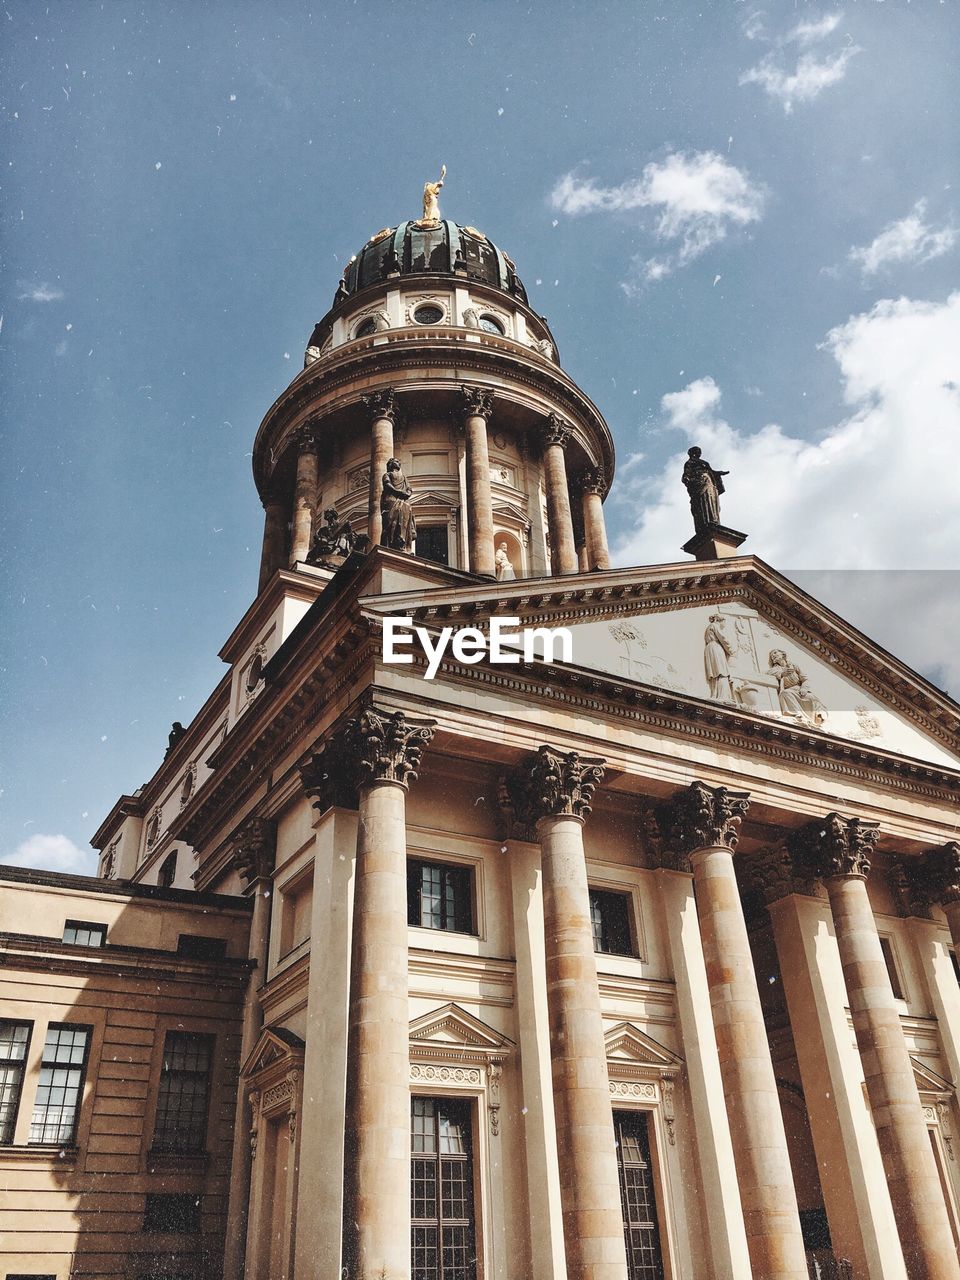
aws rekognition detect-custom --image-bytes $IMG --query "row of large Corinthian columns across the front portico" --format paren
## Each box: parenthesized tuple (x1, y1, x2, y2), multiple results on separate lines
(231, 705, 960, 1280)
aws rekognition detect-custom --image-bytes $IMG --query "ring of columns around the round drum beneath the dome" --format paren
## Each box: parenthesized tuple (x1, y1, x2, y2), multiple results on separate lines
(260, 384, 611, 589)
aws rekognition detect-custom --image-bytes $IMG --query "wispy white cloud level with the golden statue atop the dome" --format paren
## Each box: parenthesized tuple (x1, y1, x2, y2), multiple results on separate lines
(550, 151, 765, 291)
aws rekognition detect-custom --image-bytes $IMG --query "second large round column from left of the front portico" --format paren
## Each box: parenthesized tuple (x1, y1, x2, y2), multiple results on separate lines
(507, 746, 626, 1280)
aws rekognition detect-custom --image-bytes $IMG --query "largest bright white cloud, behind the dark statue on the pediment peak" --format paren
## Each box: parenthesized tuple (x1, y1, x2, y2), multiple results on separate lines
(614, 292, 960, 576)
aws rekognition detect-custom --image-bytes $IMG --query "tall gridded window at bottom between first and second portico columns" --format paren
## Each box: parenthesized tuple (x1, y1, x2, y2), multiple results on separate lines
(410, 1097, 476, 1280)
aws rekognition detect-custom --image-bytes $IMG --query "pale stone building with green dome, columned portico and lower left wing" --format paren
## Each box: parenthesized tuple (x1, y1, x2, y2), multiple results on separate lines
(0, 180, 960, 1280)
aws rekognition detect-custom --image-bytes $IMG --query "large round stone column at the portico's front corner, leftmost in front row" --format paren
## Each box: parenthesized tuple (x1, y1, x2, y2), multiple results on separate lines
(335, 707, 434, 1280)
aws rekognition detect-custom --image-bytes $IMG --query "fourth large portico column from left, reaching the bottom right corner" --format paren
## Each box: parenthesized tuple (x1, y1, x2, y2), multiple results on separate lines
(791, 813, 960, 1280)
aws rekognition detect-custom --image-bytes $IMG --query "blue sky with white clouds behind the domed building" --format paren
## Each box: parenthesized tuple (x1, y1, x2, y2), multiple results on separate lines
(0, 0, 960, 869)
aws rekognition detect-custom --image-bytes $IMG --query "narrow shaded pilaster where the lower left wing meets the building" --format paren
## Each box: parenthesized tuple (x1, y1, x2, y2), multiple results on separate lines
(224, 818, 276, 1280)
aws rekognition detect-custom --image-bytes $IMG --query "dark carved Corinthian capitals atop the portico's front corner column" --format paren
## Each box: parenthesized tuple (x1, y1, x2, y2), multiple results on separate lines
(300, 707, 436, 812)
